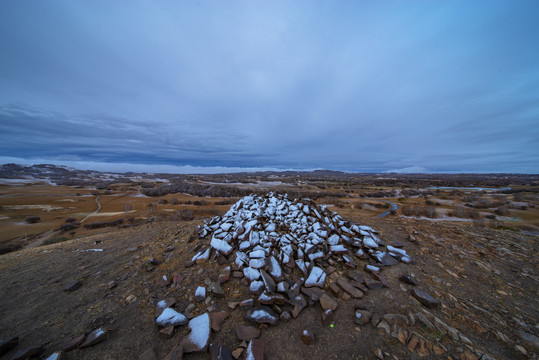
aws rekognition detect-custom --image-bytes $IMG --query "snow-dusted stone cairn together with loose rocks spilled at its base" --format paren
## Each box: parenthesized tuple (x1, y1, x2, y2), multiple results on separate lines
(158, 193, 411, 358)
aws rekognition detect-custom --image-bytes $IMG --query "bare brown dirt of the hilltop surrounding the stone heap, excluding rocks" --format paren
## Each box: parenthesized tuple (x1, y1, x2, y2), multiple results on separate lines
(0, 209, 539, 359)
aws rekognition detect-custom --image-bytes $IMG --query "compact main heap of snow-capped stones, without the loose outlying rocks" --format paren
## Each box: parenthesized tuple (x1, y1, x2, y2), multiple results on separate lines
(196, 193, 411, 294)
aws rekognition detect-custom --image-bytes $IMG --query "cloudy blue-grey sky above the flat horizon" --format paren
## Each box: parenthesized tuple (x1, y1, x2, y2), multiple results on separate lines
(0, 0, 539, 173)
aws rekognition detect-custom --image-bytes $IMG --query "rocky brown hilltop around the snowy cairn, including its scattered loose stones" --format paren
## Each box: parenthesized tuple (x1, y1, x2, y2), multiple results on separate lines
(0, 194, 539, 359)
